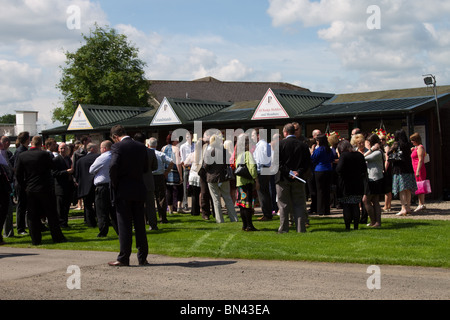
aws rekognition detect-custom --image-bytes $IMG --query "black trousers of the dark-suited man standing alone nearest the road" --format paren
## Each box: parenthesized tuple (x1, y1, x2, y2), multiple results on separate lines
(115, 199, 148, 264)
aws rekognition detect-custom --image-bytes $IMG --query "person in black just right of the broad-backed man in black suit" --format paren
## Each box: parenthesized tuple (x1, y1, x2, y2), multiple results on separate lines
(52, 142, 73, 228)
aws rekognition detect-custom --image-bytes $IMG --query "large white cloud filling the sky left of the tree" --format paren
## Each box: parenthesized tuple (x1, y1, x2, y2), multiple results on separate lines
(0, 0, 107, 125)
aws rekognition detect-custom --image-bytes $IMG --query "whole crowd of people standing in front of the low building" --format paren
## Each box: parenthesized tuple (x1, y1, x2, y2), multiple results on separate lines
(0, 122, 426, 249)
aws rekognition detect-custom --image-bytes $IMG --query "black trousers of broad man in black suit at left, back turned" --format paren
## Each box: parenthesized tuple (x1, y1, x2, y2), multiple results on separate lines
(26, 192, 65, 245)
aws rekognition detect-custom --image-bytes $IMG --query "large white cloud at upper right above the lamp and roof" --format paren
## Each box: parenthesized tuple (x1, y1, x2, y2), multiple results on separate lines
(267, 0, 450, 91)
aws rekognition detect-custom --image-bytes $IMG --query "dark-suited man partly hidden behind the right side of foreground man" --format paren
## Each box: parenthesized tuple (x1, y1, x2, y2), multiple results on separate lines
(133, 132, 158, 230)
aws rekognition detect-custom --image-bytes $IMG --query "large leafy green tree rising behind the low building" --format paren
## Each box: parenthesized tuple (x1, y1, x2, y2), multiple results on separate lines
(53, 25, 149, 124)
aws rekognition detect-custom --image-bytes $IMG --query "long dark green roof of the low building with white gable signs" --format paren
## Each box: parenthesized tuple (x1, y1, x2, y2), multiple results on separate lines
(43, 86, 450, 134)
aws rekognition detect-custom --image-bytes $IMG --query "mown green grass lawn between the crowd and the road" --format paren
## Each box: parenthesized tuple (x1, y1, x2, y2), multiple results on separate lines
(5, 214, 450, 268)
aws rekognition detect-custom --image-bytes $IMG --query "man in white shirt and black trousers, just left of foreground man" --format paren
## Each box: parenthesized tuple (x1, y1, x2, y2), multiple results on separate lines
(89, 140, 119, 238)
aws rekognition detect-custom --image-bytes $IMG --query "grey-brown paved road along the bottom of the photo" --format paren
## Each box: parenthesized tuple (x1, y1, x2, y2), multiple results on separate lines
(0, 247, 450, 303)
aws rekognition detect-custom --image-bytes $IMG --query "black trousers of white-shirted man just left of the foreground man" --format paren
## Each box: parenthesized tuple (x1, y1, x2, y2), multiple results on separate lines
(95, 184, 119, 237)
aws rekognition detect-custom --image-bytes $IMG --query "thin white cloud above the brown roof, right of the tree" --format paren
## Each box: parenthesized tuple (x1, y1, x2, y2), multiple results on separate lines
(115, 25, 253, 80)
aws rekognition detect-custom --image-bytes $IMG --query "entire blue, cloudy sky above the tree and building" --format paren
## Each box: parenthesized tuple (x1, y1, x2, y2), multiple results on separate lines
(0, 0, 450, 127)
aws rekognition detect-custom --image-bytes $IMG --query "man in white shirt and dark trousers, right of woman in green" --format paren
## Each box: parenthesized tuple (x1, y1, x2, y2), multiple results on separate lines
(252, 129, 273, 221)
